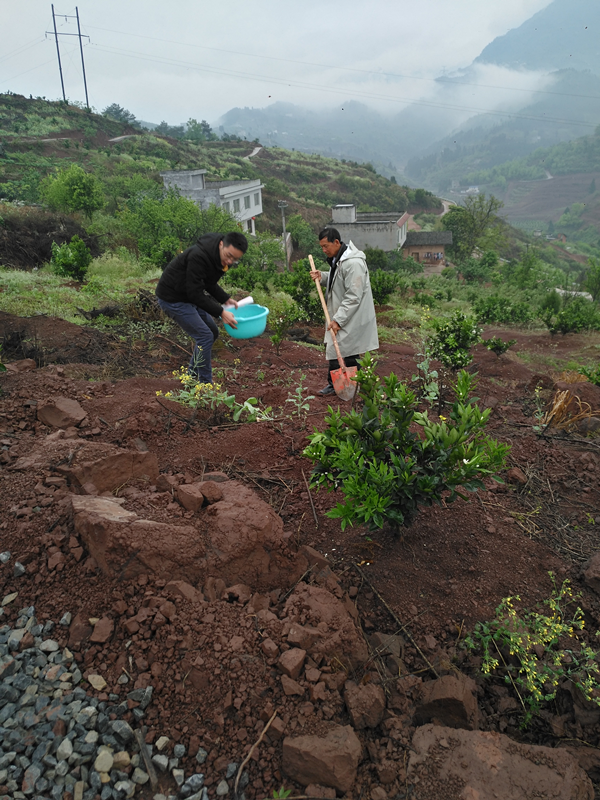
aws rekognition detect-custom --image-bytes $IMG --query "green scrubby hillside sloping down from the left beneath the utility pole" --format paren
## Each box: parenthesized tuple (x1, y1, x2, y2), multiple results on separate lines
(0, 95, 439, 238)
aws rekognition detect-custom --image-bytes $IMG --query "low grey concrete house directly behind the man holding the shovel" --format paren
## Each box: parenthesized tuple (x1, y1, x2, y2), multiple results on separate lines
(331, 203, 408, 252)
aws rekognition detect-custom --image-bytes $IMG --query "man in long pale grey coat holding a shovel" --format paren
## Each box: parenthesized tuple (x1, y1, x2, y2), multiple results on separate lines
(311, 228, 379, 395)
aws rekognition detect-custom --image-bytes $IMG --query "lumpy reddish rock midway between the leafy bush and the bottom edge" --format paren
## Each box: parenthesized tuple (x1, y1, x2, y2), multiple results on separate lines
(285, 582, 369, 668)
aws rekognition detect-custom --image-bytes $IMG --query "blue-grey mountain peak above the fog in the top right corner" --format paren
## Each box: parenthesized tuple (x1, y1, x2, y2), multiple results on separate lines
(474, 0, 600, 74)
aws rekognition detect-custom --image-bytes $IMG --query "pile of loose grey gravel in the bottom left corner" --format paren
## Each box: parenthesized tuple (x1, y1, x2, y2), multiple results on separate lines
(0, 594, 248, 800)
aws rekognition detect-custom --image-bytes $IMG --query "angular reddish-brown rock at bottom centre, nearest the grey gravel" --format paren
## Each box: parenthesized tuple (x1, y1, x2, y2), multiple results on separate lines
(281, 725, 362, 792)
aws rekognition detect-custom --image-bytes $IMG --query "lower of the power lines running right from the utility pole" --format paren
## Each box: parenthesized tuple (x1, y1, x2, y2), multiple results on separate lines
(92, 44, 597, 128)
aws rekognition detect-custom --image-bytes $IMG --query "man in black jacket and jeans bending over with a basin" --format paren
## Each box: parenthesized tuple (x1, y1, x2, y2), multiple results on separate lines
(156, 231, 248, 383)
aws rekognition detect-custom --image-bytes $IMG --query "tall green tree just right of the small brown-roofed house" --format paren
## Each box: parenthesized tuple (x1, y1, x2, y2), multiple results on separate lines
(442, 194, 504, 263)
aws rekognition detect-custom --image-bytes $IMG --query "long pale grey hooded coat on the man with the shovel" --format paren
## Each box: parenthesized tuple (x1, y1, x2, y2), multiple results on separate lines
(321, 242, 379, 359)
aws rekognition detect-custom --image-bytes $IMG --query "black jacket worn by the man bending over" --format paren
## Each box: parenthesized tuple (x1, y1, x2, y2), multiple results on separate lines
(156, 233, 229, 317)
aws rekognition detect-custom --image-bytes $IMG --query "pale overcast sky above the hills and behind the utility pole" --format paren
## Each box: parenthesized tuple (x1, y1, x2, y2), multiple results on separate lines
(0, 0, 550, 124)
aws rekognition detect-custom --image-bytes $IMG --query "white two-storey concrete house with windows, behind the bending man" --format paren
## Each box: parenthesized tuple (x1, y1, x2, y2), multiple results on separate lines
(160, 169, 263, 236)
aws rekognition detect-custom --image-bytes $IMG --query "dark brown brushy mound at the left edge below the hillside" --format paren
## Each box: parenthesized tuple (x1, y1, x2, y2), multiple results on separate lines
(0, 204, 100, 269)
